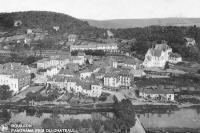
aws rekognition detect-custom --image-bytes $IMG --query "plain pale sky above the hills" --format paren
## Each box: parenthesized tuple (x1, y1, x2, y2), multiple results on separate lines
(0, 0, 200, 20)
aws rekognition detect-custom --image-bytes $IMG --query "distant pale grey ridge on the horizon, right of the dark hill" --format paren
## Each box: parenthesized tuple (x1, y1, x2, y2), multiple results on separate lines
(86, 18, 200, 29)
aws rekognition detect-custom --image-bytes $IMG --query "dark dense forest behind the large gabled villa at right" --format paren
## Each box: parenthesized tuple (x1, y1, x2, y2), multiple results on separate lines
(112, 26, 200, 61)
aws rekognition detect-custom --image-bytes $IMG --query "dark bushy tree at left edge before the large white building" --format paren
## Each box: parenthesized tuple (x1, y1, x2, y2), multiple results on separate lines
(0, 85, 13, 100)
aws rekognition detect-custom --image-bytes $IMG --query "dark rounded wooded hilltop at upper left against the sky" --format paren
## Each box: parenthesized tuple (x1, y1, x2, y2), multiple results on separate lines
(0, 11, 105, 34)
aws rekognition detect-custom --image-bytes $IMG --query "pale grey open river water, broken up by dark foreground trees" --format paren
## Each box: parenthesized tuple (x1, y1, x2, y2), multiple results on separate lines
(0, 108, 200, 132)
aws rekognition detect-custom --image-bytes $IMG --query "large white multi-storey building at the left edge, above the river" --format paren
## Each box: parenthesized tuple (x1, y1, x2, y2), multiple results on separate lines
(0, 63, 31, 93)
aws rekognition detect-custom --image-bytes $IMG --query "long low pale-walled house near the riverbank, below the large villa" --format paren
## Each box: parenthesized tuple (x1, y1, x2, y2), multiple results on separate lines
(139, 88, 174, 101)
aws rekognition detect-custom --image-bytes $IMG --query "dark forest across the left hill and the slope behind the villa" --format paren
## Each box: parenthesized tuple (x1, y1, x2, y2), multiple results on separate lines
(0, 11, 200, 62)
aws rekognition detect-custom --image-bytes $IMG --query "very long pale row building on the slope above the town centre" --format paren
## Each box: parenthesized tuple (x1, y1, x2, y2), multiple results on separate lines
(70, 42, 118, 52)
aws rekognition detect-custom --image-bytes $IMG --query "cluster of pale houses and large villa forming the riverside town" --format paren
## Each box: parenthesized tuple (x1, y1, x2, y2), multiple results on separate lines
(0, 29, 198, 104)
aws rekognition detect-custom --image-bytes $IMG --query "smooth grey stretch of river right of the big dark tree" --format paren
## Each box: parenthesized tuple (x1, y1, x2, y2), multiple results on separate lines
(140, 108, 200, 128)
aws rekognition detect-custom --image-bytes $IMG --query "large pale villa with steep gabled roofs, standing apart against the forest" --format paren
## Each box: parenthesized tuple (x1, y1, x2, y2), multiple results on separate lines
(143, 43, 182, 68)
